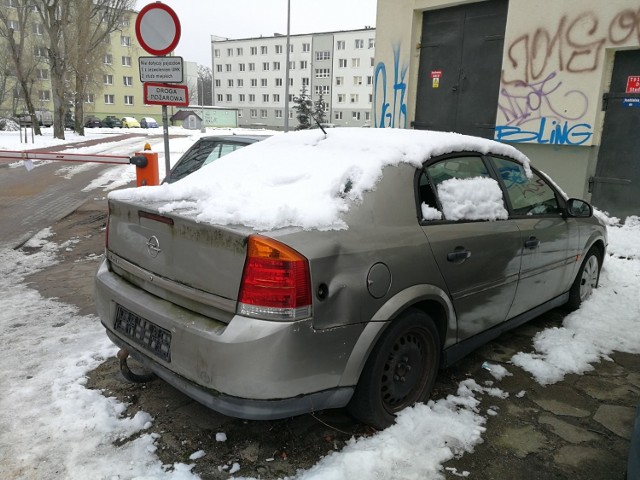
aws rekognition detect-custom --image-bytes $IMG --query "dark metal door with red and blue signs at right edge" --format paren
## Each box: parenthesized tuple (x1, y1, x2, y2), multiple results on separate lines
(589, 50, 640, 219)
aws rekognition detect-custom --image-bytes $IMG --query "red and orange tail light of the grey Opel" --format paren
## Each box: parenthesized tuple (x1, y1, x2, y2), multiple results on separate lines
(238, 235, 311, 320)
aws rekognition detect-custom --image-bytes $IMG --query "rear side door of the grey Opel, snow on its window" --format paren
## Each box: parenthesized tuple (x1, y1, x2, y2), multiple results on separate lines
(419, 154, 522, 341)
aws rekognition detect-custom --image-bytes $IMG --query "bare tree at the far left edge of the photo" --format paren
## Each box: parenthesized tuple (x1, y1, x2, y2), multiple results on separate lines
(0, 0, 42, 135)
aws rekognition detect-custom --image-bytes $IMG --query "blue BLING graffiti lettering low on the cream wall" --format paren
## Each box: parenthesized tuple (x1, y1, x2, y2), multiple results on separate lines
(495, 118, 593, 145)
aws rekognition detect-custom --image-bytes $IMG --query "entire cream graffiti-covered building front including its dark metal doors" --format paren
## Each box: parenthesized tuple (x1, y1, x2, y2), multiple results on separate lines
(372, 0, 640, 218)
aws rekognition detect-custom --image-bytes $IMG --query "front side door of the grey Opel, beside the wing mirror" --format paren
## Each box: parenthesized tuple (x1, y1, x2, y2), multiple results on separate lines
(491, 157, 579, 317)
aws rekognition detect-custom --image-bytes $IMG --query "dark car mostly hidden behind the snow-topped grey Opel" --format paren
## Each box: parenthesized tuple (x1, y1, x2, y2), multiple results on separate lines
(163, 135, 268, 183)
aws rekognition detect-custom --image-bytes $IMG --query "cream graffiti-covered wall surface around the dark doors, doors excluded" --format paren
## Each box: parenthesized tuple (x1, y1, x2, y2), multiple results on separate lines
(372, 0, 640, 198)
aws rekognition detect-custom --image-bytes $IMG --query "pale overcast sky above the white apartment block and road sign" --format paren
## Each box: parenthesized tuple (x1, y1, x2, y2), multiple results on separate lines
(136, 0, 377, 66)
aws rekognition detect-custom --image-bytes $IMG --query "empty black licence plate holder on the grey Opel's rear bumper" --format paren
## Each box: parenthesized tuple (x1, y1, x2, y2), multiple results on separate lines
(114, 305, 171, 362)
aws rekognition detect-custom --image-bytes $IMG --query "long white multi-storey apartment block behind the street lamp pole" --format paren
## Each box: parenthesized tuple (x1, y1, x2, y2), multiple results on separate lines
(211, 28, 375, 129)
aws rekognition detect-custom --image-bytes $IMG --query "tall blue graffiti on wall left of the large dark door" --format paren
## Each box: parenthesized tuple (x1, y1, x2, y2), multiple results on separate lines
(373, 45, 409, 128)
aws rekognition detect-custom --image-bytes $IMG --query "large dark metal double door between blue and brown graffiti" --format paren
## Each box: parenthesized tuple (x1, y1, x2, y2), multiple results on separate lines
(413, 0, 508, 138)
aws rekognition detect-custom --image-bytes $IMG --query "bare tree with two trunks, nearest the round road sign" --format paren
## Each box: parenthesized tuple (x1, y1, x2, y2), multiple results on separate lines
(31, 0, 135, 138)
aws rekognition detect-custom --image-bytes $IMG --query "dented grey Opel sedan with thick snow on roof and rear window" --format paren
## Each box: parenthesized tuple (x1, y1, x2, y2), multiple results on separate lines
(96, 128, 607, 428)
